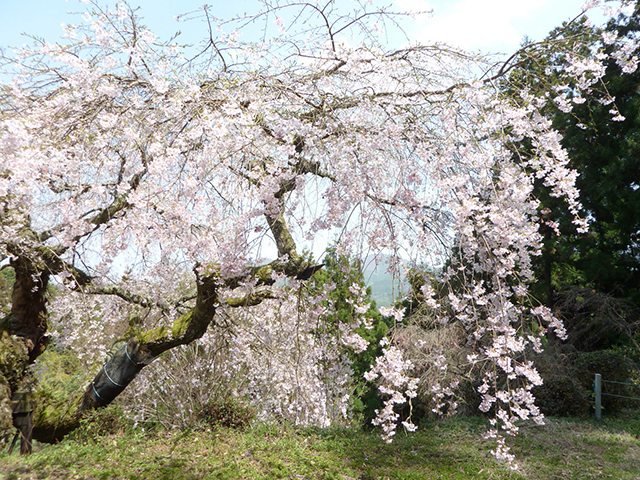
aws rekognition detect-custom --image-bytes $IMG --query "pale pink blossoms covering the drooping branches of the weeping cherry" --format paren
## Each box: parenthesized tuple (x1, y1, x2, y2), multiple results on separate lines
(0, 2, 638, 459)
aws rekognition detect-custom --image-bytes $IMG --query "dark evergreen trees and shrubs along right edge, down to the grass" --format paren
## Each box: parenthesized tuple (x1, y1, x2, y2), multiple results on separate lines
(510, 8, 640, 415)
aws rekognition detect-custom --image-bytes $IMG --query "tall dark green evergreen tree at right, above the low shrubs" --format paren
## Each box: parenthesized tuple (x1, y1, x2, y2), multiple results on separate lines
(507, 7, 640, 360)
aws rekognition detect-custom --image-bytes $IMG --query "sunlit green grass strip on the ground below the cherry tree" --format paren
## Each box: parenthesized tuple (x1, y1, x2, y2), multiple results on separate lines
(0, 411, 640, 480)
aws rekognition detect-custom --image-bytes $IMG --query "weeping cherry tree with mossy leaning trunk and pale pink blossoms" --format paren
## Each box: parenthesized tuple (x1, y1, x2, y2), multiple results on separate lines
(0, 0, 637, 459)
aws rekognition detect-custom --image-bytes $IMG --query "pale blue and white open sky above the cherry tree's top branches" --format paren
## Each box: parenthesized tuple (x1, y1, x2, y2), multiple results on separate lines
(0, 0, 604, 54)
